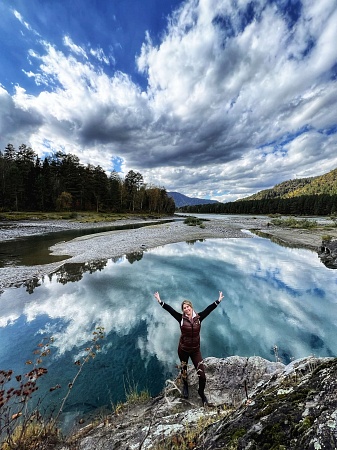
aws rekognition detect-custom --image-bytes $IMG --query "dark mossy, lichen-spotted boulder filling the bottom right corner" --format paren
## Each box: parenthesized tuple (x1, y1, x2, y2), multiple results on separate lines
(195, 358, 337, 450)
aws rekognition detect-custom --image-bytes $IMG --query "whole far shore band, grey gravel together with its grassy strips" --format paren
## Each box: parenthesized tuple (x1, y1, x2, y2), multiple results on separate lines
(0, 213, 337, 293)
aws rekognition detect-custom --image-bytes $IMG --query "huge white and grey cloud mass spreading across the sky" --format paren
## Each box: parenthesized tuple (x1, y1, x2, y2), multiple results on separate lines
(1, 0, 337, 201)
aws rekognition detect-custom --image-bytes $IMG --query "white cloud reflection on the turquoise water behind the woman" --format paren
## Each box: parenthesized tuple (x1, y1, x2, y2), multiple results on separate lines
(0, 238, 337, 366)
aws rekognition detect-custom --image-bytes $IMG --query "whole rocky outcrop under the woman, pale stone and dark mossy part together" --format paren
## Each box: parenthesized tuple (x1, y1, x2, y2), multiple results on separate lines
(62, 357, 337, 450)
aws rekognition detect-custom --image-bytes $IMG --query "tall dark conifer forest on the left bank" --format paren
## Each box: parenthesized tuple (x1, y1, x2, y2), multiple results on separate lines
(0, 144, 175, 214)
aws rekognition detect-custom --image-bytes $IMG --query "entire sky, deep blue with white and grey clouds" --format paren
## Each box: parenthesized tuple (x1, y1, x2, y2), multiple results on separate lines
(0, 0, 337, 202)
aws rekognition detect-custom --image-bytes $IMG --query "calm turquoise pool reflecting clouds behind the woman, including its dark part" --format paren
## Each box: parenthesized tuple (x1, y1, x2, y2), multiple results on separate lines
(0, 237, 337, 428)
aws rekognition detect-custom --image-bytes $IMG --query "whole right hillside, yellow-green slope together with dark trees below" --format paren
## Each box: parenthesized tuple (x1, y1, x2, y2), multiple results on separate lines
(180, 169, 337, 216)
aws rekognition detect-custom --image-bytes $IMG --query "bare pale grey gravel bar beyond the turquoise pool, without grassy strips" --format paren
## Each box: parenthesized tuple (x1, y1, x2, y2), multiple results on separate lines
(0, 216, 337, 292)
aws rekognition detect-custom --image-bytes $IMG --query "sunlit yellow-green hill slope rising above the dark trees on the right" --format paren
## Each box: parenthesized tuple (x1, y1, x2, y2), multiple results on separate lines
(240, 168, 337, 201)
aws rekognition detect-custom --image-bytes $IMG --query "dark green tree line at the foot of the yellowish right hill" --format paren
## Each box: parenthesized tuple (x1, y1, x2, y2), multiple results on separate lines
(179, 194, 337, 216)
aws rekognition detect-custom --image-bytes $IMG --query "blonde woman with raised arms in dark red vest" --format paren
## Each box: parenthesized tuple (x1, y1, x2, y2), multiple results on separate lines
(154, 291, 224, 406)
